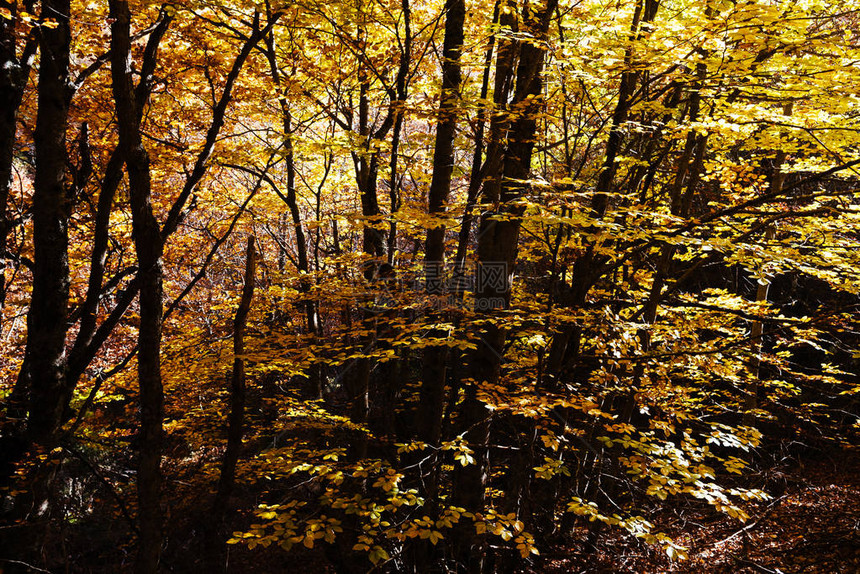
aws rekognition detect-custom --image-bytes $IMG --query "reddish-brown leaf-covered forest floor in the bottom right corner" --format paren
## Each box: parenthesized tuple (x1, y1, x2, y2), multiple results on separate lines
(544, 451, 860, 574)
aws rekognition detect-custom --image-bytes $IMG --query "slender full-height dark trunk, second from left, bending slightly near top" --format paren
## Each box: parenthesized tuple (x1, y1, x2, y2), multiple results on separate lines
(110, 0, 164, 573)
